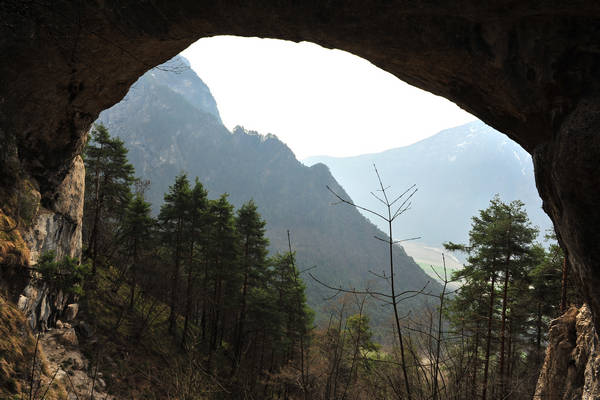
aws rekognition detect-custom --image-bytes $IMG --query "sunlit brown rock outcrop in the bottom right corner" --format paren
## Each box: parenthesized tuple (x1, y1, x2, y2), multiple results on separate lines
(534, 305, 600, 400)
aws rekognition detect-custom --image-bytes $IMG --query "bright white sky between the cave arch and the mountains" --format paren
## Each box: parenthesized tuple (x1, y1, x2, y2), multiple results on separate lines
(182, 36, 475, 160)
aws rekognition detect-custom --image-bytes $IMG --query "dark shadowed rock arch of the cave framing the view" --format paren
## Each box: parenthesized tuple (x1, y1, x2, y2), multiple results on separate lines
(0, 0, 600, 328)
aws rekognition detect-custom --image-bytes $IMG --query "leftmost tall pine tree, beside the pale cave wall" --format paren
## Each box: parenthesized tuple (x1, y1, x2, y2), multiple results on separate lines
(84, 124, 135, 275)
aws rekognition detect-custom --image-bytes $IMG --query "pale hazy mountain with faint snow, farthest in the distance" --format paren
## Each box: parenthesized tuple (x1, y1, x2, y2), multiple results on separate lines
(304, 122, 552, 250)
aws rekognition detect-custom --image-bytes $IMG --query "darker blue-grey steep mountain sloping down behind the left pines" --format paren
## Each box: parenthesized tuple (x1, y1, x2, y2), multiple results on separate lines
(99, 57, 438, 322)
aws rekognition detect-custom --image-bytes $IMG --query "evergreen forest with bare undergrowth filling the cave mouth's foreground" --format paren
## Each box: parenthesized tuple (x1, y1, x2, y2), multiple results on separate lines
(8, 125, 580, 400)
